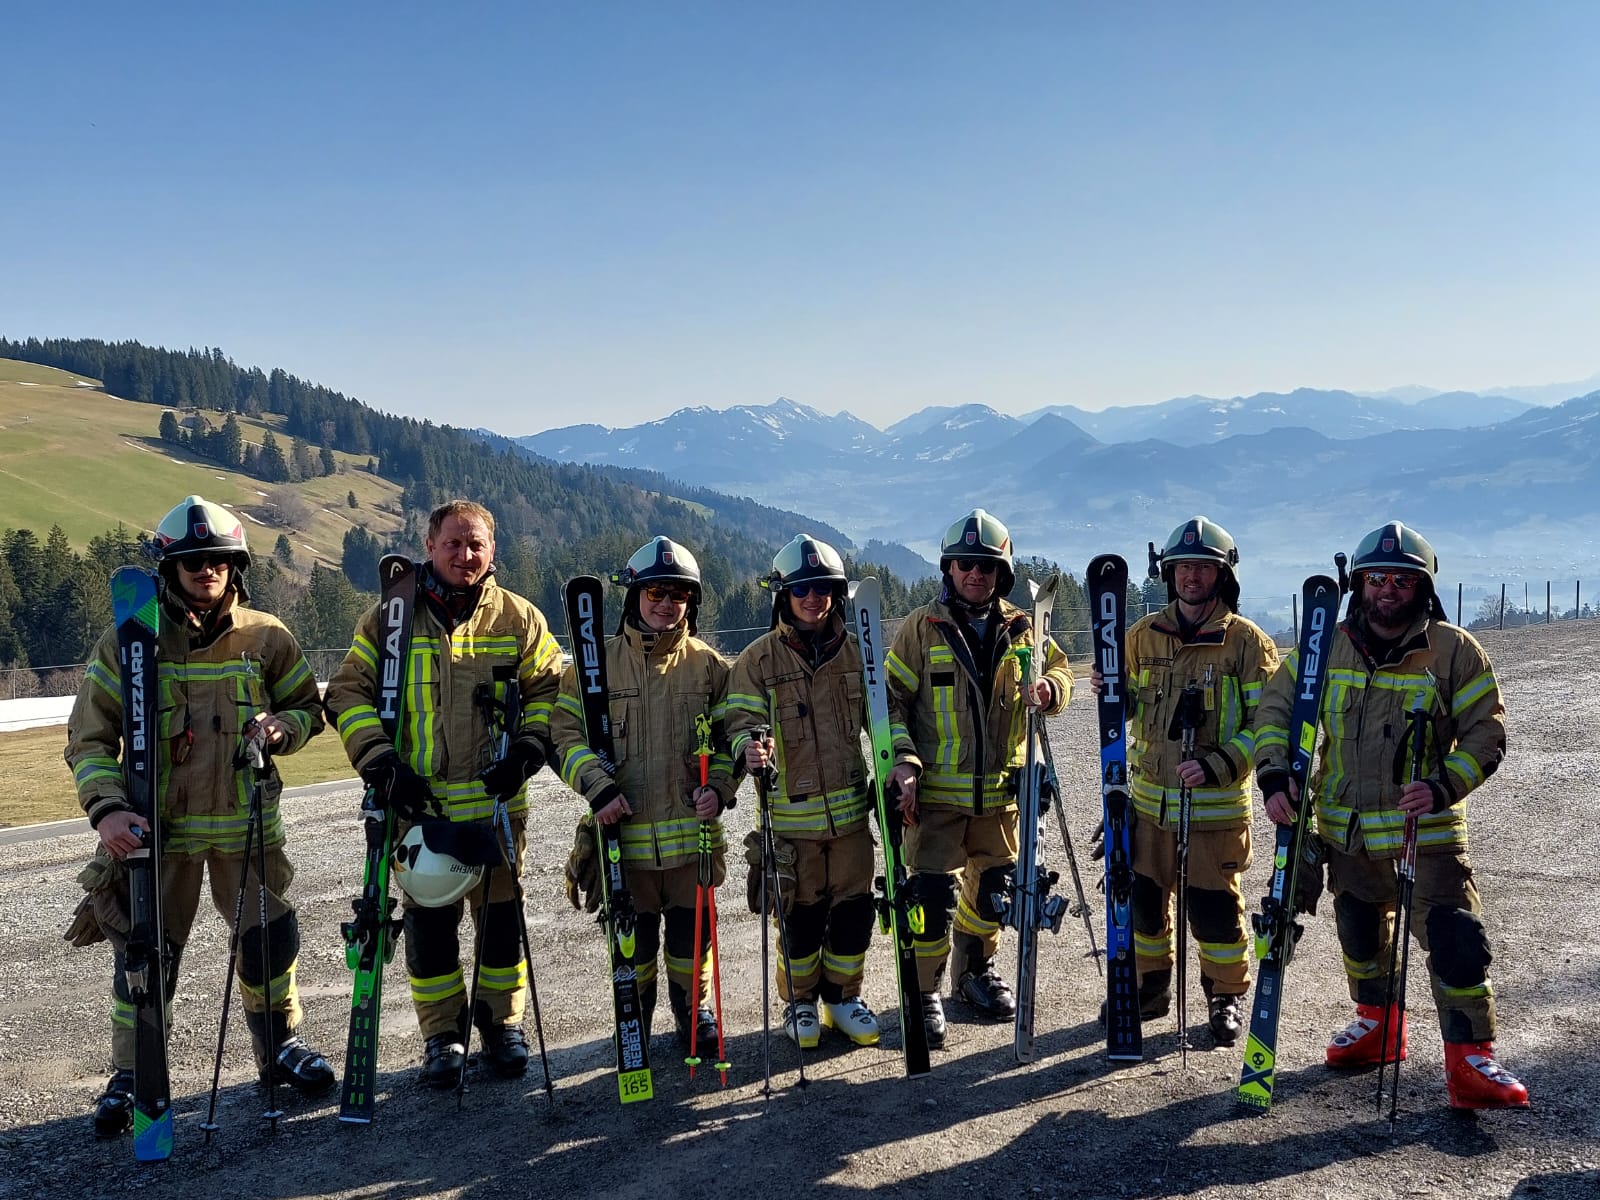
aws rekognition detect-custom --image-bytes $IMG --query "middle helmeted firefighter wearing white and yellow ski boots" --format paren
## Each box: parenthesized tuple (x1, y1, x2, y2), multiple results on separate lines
(728, 533, 878, 1048)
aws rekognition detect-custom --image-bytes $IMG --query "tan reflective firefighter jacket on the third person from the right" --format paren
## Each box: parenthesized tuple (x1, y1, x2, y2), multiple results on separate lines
(885, 600, 1072, 816)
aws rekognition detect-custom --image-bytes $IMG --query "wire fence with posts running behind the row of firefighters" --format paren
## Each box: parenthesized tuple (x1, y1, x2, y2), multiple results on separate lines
(0, 579, 1600, 699)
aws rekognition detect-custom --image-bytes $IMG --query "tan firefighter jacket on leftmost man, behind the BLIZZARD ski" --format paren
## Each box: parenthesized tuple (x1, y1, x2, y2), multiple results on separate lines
(66, 587, 322, 854)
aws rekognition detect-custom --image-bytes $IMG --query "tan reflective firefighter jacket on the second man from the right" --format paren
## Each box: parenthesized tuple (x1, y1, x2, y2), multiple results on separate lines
(1128, 600, 1278, 829)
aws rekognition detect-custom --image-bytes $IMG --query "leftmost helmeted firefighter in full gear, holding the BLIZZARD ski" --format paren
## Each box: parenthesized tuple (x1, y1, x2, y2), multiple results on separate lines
(66, 496, 334, 1138)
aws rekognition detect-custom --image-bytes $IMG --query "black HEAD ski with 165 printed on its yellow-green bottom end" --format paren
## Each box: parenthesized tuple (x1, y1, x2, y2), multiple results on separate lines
(566, 574, 654, 1104)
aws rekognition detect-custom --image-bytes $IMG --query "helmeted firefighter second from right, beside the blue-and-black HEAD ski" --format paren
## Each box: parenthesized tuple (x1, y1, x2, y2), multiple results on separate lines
(1091, 517, 1278, 1046)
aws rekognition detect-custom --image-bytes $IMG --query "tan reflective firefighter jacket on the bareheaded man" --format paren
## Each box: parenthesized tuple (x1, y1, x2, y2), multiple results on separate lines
(326, 574, 562, 821)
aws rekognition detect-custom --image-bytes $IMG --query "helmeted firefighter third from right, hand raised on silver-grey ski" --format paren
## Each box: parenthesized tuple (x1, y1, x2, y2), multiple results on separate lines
(885, 509, 1072, 1048)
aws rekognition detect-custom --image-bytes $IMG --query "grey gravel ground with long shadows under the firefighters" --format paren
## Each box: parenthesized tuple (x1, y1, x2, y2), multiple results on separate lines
(0, 622, 1600, 1200)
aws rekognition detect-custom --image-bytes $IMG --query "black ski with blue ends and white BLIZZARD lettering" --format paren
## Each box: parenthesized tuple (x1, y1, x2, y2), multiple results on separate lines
(110, 566, 173, 1162)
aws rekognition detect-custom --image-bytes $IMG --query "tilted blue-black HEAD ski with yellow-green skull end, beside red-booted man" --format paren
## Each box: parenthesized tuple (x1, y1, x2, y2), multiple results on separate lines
(1238, 574, 1339, 1110)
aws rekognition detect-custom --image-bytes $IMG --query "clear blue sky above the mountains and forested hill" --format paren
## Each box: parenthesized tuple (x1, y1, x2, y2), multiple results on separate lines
(0, 0, 1600, 435)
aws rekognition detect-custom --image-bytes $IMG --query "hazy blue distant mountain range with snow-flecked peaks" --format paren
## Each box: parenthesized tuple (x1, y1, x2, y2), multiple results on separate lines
(517, 389, 1600, 611)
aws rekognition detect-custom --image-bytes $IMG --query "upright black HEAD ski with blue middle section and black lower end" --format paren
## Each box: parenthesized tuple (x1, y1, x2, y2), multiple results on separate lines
(1088, 554, 1144, 1062)
